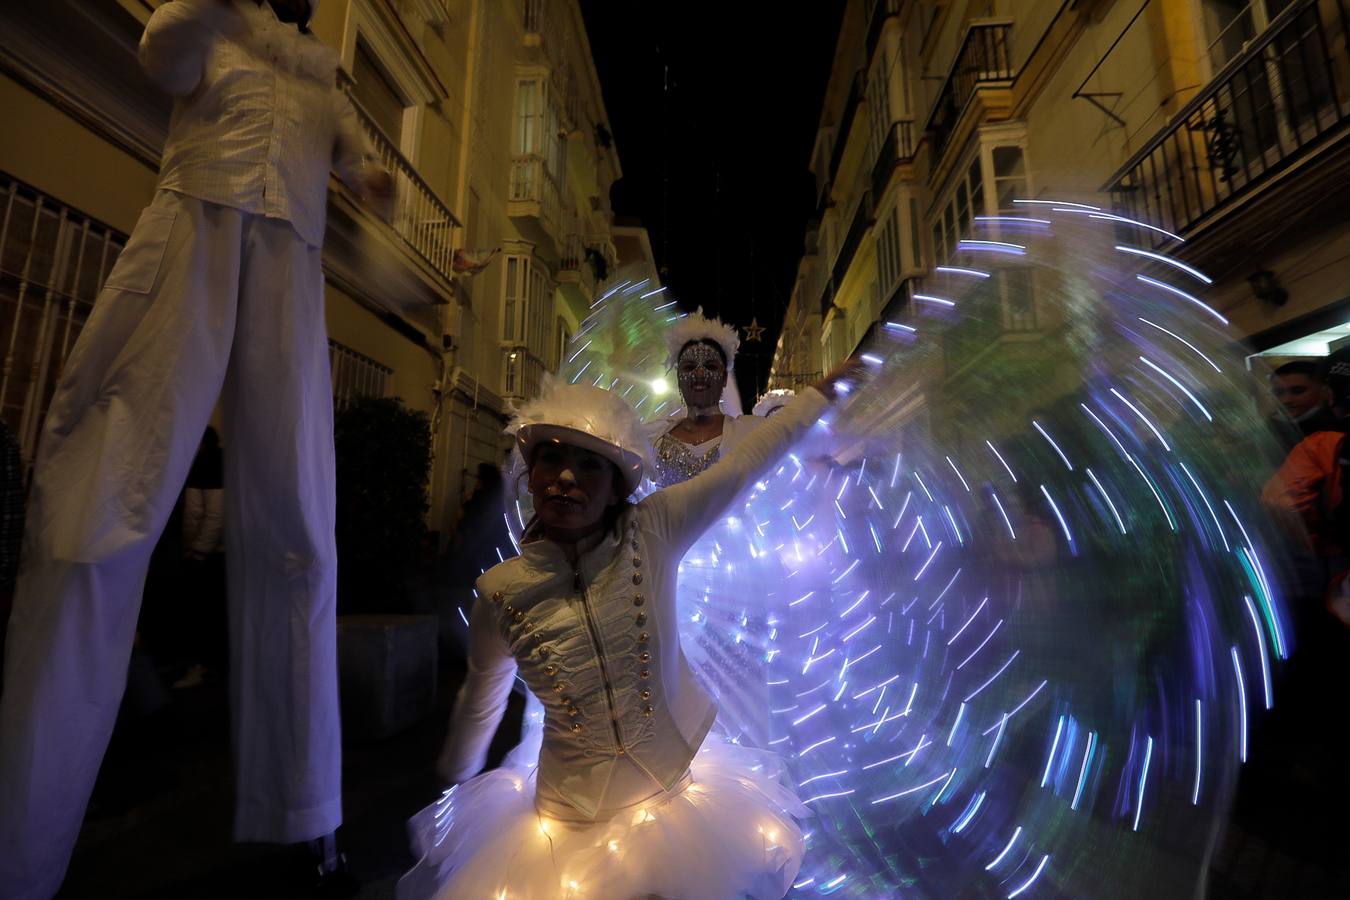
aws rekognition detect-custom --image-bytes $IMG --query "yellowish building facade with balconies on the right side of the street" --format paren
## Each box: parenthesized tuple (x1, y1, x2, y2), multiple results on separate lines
(771, 0, 1350, 386)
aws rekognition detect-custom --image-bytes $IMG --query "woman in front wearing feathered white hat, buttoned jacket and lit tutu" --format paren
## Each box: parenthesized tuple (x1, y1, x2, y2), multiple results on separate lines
(400, 363, 855, 900)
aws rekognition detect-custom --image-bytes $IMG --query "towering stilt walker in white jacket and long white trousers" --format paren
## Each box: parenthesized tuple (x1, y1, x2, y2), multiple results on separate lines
(0, 0, 392, 899)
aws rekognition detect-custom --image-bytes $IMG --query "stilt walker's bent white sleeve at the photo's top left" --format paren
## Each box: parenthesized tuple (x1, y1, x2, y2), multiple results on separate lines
(140, 0, 244, 97)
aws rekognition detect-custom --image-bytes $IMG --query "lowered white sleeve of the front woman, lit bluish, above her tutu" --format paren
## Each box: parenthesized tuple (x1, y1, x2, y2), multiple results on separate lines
(436, 596, 516, 784)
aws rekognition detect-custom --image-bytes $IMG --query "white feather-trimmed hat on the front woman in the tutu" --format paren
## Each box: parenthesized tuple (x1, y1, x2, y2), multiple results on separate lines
(505, 375, 652, 494)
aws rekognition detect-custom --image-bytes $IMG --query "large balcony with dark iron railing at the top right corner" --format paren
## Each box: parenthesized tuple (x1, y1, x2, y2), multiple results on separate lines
(1106, 0, 1350, 247)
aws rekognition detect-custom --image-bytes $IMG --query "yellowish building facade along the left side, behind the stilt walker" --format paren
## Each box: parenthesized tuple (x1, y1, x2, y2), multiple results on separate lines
(0, 0, 621, 545)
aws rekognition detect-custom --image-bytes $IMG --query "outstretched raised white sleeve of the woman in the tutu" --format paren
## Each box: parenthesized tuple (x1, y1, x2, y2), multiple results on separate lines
(641, 389, 829, 551)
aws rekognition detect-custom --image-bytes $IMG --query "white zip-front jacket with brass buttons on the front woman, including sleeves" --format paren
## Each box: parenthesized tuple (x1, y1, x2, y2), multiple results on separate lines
(440, 390, 826, 819)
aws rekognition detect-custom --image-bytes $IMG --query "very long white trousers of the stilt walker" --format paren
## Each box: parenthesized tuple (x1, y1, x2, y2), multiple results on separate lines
(0, 190, 342, 900)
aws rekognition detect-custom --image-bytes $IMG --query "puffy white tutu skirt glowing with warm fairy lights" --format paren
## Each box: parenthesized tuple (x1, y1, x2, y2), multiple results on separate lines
(398, 733, 809, 900)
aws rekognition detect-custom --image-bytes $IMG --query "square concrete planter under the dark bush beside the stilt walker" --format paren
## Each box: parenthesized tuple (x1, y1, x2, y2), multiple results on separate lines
(338, 615, 437, 741)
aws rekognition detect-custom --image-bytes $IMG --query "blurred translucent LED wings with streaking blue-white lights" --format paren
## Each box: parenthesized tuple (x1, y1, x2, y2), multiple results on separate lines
(426, 209, 1291, 897)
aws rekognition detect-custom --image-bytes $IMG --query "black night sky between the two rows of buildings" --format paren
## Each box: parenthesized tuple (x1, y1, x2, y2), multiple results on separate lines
(581, 0, 844, 397)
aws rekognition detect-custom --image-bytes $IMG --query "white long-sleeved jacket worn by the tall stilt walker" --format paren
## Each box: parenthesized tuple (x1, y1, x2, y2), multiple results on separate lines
(140, 0, 374, 247)
